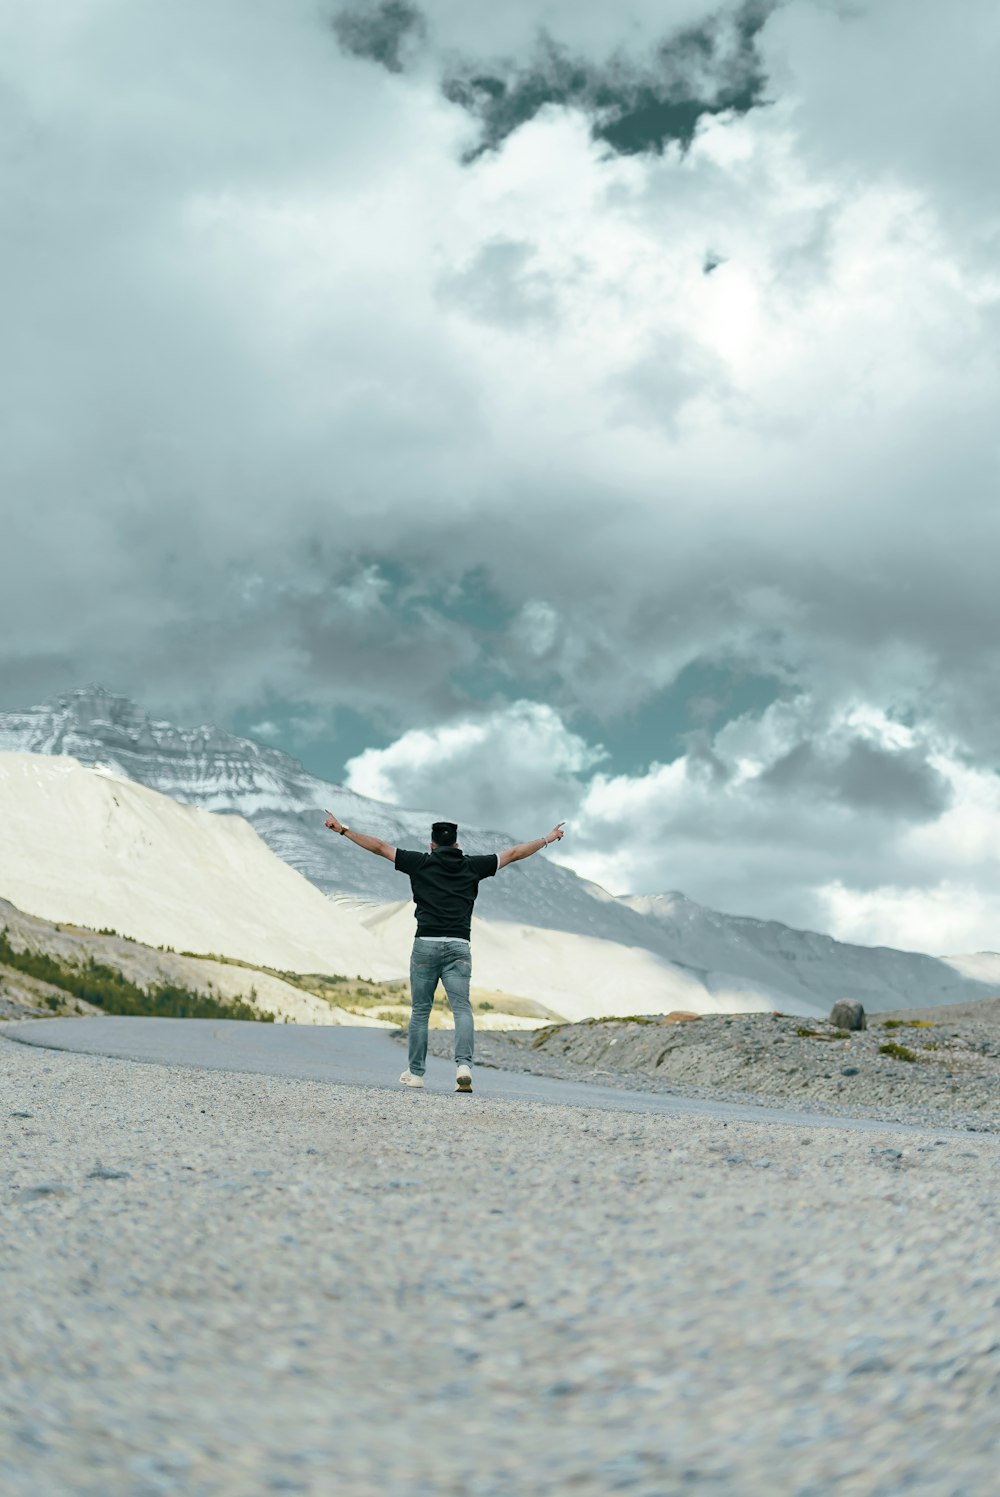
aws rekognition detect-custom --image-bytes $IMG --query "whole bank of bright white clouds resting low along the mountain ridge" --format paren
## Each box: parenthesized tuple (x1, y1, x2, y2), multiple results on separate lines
(339, 699, 1000, 954)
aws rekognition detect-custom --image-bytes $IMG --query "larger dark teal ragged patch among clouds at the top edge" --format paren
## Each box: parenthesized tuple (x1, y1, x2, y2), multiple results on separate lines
(443, 3, 774, 160)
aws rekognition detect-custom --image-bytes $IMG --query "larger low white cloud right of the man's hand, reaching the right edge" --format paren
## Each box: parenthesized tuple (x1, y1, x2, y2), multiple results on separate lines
(561, 702, 1000, 952)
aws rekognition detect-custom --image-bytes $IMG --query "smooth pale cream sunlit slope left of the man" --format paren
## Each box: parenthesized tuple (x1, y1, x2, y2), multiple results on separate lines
(0, 753, 400, 979)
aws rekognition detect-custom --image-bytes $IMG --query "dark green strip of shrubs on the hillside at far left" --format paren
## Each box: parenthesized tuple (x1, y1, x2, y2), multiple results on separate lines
(0, 925, 274, 1024)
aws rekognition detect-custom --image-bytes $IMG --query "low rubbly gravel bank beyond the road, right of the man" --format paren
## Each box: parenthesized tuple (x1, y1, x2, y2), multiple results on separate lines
(428, 1000, 1000, 1132)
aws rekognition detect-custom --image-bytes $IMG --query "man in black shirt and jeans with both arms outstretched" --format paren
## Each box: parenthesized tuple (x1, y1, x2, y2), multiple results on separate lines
(325, 811, 564, 1091)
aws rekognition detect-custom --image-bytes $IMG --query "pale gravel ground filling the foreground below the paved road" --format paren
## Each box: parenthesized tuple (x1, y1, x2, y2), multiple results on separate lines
(0, 1040, 1000, 1497)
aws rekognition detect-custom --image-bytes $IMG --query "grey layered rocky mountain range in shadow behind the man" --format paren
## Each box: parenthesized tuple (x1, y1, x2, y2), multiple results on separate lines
(0, 689, 1000, 1012)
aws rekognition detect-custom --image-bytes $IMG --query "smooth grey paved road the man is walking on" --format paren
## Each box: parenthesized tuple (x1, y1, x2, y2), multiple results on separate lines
(0, 1016, 967, 1136)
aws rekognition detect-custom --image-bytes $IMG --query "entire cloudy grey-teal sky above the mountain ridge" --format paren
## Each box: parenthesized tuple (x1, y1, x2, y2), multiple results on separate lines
(0, 0, 1000, 952)
